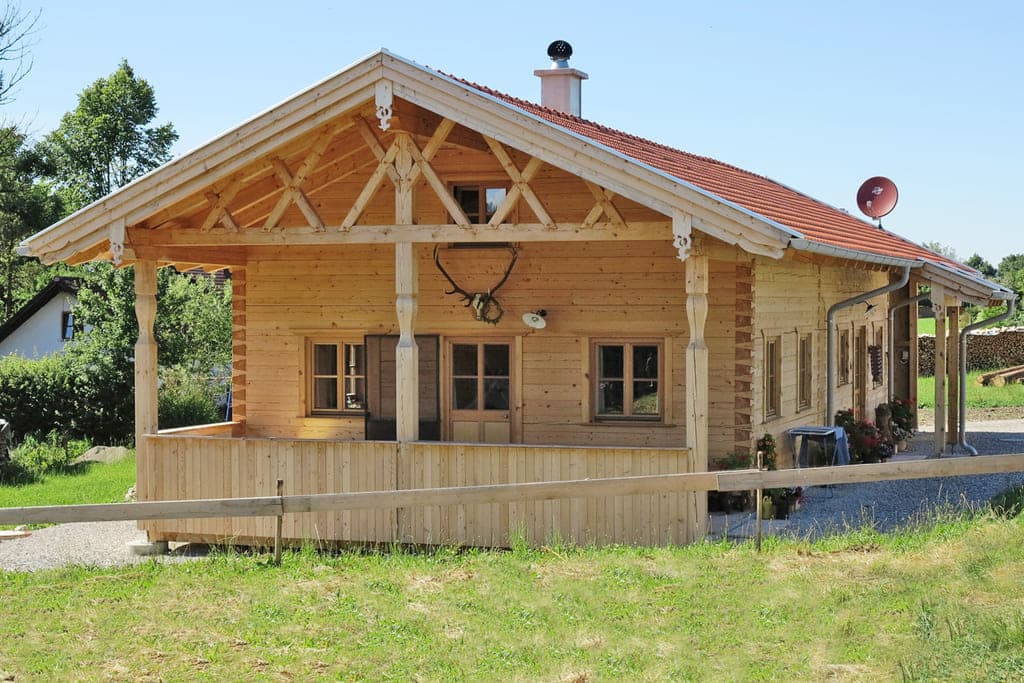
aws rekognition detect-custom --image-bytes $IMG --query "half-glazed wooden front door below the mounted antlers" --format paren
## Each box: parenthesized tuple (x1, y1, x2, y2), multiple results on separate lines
(447, 340, 513, 443)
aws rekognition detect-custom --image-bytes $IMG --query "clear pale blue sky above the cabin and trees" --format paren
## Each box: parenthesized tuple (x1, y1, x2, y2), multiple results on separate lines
(3, 0, 1024, 265)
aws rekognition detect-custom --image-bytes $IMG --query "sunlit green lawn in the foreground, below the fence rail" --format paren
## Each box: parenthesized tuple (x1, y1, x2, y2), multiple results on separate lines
(0, 514, 1024, 681)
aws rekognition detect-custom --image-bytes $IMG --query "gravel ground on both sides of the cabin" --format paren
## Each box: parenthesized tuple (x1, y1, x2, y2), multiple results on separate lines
(8, 419, 1024, 571)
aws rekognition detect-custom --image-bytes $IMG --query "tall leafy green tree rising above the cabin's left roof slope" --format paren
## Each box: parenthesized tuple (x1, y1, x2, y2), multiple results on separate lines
(40, 59, 178, 211)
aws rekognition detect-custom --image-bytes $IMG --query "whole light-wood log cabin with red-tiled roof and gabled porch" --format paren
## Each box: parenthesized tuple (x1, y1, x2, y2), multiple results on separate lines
(20, 46, 1010, 546)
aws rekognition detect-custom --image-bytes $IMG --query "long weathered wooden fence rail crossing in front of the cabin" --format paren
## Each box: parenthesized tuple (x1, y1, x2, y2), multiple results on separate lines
(0, 454, 1024, 524)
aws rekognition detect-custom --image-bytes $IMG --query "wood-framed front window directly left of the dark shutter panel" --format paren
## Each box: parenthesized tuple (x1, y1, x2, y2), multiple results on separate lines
(306, 340, 367, 415)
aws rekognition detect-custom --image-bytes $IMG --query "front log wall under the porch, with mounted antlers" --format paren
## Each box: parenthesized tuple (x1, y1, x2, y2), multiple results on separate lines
(236, 242, 751, 464)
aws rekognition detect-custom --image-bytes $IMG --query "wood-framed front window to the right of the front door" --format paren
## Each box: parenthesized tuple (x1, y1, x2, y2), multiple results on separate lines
(591, 340, 664, 421)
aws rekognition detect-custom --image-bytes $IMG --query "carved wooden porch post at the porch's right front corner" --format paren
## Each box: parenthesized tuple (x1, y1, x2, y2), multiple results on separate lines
(686, 241, 709, 541)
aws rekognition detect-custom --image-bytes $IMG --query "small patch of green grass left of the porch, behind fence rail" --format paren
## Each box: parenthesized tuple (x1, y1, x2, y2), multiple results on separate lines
(0, 456, 135, 508)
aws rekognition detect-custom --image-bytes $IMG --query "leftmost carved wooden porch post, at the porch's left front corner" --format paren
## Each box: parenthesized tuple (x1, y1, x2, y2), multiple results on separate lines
(135, 260, 158, 501)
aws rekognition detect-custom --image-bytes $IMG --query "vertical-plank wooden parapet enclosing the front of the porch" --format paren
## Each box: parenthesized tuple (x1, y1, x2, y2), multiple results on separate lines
(138, 432, 706, 547)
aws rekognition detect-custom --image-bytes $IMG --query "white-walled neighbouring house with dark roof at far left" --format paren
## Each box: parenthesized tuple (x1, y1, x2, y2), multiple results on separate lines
(0, 278, 79, 358)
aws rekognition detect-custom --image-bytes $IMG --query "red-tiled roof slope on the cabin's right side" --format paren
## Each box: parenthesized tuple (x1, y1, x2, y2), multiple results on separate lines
(462, 81, 981, 278)
